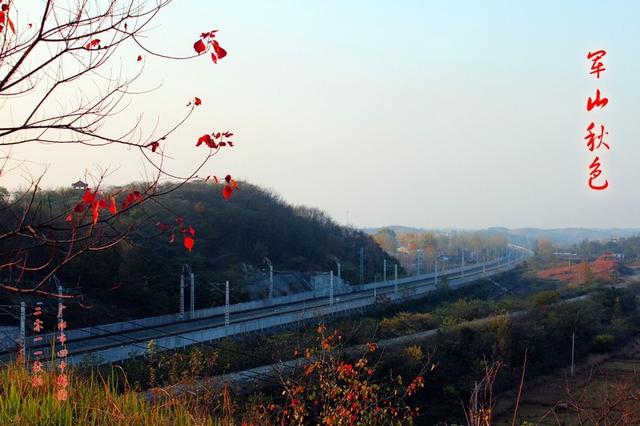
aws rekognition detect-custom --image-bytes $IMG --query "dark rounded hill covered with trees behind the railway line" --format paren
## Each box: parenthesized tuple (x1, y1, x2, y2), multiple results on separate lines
(3, 182, 394, 316)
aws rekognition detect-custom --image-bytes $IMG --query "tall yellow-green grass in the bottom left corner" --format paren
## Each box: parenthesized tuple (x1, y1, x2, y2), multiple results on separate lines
(0, 364, 232, 426)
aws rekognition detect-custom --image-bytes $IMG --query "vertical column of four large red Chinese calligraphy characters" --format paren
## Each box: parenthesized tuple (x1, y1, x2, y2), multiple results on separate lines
(584, 50, 611, 191)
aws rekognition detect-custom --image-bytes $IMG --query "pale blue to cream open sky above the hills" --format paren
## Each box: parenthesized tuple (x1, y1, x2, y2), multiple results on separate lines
(0, 0, 640, 229)
